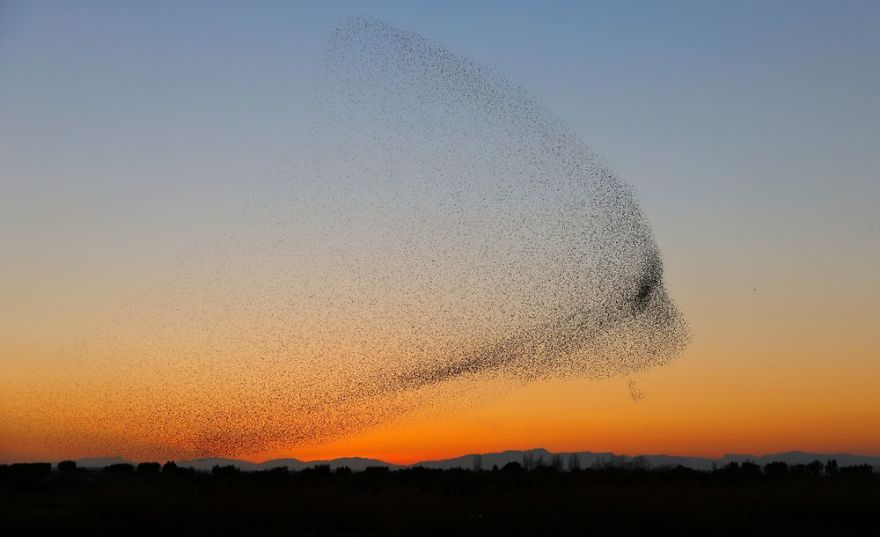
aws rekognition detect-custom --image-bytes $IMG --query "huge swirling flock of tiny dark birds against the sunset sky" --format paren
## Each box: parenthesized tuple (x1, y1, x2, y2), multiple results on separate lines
(49, 18, 688, 456)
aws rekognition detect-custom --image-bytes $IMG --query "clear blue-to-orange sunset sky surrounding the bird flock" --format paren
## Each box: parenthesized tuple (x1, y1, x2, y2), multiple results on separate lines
(0, 1, 880, 462)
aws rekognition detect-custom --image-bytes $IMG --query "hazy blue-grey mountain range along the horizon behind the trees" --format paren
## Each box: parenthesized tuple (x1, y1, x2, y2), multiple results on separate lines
(77, 448, 880, 472)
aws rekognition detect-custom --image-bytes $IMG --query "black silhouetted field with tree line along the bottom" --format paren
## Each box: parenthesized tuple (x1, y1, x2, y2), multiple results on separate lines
(0, 463, 880, 535)
